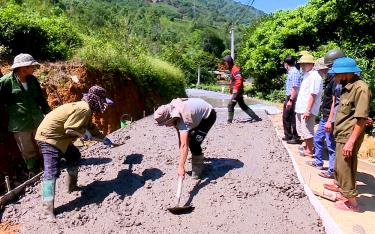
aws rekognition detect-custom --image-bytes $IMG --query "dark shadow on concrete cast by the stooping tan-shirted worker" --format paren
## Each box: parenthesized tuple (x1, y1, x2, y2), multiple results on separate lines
(56, 154, 163, 214)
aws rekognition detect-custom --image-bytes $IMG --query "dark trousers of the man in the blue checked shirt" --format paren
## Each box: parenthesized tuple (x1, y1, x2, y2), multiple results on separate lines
(283, 96, 299, 139)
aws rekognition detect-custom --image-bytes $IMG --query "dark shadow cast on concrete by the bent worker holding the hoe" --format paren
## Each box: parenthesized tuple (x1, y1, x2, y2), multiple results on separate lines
(185, 158, 244, 206)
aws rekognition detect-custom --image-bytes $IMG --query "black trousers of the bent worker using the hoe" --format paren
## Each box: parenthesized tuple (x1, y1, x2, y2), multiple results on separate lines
(189, 109, 216, 155)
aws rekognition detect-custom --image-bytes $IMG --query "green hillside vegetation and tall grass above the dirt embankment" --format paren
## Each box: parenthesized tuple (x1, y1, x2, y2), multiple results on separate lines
(0, 0, 261, 99)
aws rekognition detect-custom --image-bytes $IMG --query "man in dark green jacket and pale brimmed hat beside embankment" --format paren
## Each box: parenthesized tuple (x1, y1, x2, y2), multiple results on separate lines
(0, 54, 51, 176)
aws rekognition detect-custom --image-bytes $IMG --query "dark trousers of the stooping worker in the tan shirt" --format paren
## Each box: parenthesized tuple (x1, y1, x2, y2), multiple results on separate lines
(37, 141, 81, 180)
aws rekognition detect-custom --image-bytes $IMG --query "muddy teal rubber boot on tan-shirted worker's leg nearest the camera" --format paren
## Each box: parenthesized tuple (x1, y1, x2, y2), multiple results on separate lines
(42, 179, 56, 222)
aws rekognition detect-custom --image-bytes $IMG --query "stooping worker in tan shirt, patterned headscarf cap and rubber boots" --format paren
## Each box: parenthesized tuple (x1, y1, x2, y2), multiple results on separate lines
(35, 85, 113, 220)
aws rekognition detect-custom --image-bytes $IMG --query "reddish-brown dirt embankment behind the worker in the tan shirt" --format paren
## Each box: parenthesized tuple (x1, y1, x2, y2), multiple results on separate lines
(2, 62, 161, 133)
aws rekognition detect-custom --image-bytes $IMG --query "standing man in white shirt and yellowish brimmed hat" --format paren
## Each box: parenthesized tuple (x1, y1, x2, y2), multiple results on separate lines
(295, 54, 323, 157)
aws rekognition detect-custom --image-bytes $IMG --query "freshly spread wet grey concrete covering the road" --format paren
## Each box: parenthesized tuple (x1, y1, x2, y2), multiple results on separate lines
(2, 89, 324, 234)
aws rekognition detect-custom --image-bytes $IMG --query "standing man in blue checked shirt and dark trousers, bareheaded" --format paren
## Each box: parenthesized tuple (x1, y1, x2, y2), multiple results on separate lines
(283, 56, 302, 144)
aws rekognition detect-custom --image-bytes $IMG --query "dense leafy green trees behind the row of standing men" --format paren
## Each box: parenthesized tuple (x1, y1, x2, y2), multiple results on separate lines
(239, 0, 375, 110)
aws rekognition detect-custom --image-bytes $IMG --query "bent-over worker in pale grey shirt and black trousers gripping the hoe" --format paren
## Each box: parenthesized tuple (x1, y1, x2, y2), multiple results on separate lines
(154, 98, 216, 179)
